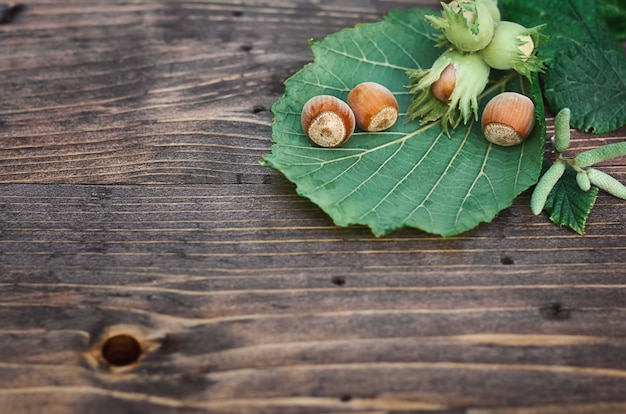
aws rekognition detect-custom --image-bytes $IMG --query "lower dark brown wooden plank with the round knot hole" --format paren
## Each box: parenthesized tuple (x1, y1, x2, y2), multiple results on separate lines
(0, 185, 626, 413)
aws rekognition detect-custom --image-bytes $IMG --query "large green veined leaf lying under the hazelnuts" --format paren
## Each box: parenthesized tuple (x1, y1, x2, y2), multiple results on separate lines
(262, 9, 545, 236)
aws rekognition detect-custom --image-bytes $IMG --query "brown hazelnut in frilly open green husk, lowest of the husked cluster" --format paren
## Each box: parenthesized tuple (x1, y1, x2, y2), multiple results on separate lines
(407, 50, 490, 132)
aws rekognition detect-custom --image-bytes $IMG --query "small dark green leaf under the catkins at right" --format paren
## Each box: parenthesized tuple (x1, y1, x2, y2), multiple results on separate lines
(544, 162, 598, 235)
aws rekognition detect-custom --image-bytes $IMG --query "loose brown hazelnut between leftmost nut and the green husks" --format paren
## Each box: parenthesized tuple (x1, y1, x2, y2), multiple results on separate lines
(348, 82, 398, 132)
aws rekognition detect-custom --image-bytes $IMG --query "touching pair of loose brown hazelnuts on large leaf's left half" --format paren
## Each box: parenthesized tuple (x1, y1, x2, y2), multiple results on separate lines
(301, 82, 398, 148)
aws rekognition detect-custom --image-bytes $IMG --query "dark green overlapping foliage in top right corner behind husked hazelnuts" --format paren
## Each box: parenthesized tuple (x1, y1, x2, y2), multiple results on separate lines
(500, 0, 626, 134)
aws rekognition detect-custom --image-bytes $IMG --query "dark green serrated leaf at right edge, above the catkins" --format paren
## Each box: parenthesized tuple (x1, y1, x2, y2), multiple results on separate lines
(544, 45, 626, 134)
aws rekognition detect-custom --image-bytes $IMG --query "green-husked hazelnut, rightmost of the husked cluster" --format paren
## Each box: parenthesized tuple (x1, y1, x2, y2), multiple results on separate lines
(478, 21, 546, 80)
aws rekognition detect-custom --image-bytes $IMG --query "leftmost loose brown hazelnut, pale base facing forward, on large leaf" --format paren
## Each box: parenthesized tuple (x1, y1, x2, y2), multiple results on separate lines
(301, 95, 355, 148)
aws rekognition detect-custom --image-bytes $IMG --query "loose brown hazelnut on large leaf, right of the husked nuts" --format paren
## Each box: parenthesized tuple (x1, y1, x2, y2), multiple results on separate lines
(481, 92, 535, 147)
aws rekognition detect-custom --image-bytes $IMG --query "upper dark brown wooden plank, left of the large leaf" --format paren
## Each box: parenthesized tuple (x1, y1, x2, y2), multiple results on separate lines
(0, 0, 435, 184)
